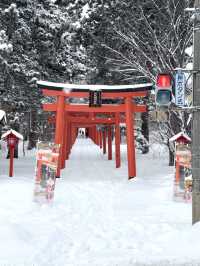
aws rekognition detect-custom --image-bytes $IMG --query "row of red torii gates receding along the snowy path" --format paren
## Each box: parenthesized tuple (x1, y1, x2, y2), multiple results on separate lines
(37, 81, 152, 179)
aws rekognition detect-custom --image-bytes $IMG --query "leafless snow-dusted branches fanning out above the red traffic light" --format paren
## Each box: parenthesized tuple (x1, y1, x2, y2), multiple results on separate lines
(101, 0, 193, 81)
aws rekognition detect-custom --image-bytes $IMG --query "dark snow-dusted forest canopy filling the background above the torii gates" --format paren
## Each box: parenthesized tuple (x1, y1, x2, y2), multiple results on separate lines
(0, 0, 194, 154)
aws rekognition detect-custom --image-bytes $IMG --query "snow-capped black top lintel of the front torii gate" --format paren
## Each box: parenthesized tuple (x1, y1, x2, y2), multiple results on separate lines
(37, 80, 153, 92)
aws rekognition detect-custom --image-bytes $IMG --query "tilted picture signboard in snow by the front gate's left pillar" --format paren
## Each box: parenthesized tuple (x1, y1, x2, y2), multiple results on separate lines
(34, 142, 59, 203)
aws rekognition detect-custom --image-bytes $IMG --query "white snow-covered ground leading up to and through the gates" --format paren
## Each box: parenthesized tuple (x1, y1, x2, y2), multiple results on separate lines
(0, 139, 200, 266)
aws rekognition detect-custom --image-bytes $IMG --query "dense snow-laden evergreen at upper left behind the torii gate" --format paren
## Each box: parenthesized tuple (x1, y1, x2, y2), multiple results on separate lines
(0, 0, 86, 148)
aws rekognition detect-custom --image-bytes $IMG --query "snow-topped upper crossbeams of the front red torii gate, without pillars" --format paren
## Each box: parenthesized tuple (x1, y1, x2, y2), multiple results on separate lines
(37, 81, 153, 113)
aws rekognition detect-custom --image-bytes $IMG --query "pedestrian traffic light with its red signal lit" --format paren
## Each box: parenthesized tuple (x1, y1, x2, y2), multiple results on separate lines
(155, 73, 173, 106)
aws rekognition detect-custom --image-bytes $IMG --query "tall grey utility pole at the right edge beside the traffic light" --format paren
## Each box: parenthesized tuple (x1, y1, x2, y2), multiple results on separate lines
(192, 0, 200, 224)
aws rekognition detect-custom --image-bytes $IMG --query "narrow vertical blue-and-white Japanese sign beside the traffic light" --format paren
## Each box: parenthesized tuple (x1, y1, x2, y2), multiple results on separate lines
(175, 72, 185, 106)
